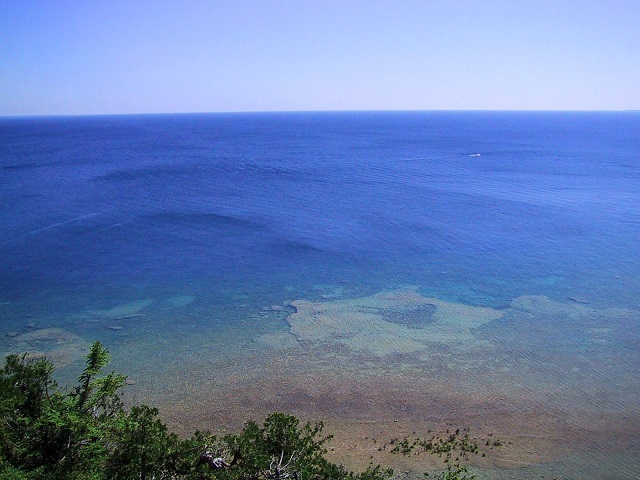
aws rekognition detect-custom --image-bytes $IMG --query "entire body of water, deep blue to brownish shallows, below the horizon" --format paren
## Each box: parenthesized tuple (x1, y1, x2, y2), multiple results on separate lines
(0, 112, 640, 478)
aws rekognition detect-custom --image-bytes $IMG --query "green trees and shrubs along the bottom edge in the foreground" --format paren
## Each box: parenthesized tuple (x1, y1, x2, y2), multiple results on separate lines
(0, 341, 484, 480)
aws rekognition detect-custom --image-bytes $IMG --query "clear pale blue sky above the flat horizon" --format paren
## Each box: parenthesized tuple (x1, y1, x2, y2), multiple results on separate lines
(0, 0, 640, 115)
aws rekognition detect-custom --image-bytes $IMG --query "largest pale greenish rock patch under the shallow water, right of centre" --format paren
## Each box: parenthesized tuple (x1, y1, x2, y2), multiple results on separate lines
(287, 288, 503, 356)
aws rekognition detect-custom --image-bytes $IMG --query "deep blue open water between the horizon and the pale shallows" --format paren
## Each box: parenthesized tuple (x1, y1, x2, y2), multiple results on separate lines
(0, 112, 640, 307)
